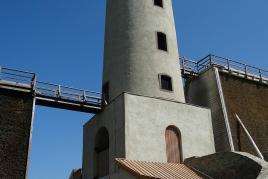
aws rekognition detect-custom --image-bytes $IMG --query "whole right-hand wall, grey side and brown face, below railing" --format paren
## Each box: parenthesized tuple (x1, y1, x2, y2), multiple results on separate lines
(185, 69, 268, 158)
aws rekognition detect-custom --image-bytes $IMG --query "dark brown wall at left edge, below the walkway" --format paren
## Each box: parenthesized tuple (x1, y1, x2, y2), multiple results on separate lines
(0, 89, 33, 179)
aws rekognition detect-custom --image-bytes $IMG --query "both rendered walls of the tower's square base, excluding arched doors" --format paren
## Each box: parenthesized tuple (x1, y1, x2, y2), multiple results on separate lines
(82, 93, 215, 179)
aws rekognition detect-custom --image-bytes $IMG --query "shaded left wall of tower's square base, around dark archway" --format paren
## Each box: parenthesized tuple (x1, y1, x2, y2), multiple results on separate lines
(82, 95, 125, 179)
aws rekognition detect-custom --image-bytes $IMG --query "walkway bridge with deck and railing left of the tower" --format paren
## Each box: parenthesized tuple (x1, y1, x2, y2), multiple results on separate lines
(0, 67, 102, 113)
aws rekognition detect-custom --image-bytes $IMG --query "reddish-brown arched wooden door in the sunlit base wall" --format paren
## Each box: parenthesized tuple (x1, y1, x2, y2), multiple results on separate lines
(165, 126, 182, 163)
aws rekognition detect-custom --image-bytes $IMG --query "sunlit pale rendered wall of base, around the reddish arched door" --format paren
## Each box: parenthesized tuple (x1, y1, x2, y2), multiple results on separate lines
(125, 94, 215, 162)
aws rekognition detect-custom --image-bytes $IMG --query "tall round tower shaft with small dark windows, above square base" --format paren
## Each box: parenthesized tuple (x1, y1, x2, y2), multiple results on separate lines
(103, 0, 185, 102)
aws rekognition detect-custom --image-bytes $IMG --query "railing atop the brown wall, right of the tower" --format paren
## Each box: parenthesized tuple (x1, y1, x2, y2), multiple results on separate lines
(180, 55, 268, 80)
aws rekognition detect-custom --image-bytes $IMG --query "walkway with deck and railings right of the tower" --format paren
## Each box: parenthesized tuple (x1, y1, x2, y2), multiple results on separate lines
(180, 55, 268, 84)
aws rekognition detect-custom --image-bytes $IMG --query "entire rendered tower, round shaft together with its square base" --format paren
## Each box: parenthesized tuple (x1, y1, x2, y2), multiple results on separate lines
(83, 0, 215, 179)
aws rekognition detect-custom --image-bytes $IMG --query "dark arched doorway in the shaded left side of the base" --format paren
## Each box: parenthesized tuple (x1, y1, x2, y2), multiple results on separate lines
(94, 127, 109, 178)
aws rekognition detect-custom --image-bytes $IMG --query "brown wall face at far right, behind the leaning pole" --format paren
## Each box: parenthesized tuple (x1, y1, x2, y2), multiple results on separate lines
(220, 73, 268, 155)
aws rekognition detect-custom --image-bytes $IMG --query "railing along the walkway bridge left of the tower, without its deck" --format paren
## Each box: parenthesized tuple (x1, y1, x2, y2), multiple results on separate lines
(0, 66, 102, 110)
